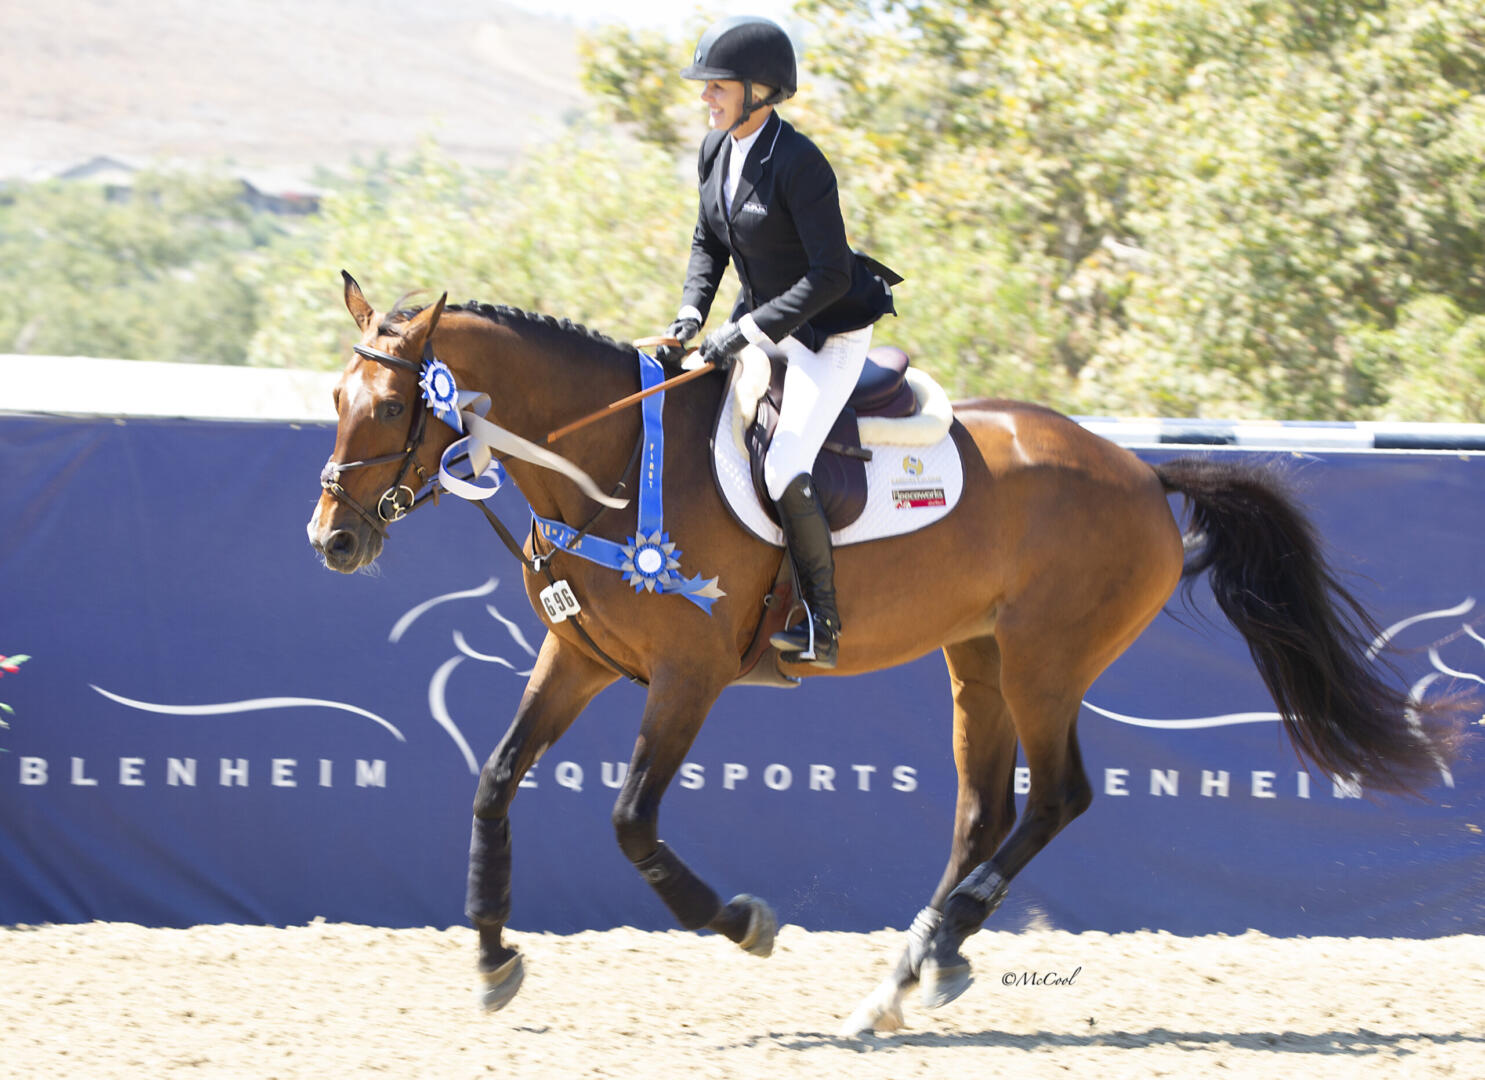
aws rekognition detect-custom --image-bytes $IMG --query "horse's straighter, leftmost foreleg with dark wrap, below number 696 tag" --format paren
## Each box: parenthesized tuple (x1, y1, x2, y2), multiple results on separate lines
(465, 634, 615, 1012)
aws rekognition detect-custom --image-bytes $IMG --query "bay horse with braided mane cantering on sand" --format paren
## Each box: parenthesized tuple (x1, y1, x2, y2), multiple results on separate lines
(309, 272, 1458, 1034)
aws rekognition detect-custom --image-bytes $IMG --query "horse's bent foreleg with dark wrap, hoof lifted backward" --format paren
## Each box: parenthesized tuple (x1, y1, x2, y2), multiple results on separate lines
(613, 671, 778, 957)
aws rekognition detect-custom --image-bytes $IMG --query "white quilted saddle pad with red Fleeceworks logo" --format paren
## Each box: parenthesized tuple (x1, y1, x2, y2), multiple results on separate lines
(711, 346, 964, 547)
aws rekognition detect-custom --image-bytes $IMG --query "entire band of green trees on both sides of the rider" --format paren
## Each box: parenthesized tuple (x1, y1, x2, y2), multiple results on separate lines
(11, 0, 1485, 420)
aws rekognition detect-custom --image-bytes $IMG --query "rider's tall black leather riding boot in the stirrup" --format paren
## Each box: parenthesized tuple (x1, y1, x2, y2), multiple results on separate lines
(769, 472, 841, 667)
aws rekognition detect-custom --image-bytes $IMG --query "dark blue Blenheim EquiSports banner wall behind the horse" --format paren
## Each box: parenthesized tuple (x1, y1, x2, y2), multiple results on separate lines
(0, 416, 1485, 936)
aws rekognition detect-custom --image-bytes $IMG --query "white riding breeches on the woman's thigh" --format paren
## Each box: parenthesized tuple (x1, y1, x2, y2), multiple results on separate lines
(763, 327, 872, 499)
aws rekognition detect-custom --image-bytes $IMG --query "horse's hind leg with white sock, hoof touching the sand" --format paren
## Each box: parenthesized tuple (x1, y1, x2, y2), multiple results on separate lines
(841, 637, 1016, 1038)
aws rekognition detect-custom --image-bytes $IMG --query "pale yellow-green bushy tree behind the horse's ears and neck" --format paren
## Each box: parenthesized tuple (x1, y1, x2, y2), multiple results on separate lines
(252, 128, 695, 367)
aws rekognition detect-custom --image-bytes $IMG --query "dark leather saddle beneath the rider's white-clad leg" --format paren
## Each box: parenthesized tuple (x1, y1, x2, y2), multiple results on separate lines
(739, 345, 918, 530)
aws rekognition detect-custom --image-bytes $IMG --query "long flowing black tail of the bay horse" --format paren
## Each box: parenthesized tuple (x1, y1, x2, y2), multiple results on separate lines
(1155, 458, 1461, 793)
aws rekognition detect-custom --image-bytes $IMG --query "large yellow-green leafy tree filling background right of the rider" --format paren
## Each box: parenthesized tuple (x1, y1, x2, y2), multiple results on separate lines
(590, 0, 1485, 419)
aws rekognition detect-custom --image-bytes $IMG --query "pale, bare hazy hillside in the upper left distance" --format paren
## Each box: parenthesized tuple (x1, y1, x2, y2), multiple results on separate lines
(0, 0, 581, 178)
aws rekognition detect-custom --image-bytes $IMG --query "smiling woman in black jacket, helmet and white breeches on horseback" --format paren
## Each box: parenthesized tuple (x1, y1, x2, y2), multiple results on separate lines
(656, 16, 900, 667)
